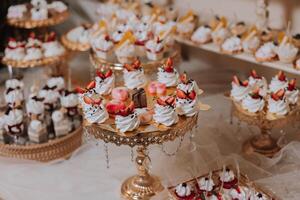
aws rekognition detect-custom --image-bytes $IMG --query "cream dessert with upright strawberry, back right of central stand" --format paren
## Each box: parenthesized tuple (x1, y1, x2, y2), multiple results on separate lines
(157, 58, 179, 87)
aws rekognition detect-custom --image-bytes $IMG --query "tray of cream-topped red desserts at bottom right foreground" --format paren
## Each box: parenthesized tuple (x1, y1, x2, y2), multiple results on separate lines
(168, 167, 277, 200)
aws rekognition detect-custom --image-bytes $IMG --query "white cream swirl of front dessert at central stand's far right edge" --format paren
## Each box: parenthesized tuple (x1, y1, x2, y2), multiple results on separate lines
(176, 98, 199, 117)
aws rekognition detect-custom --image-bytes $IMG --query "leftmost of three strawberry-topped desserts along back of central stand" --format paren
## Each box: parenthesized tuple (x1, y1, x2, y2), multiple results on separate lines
(95, 69, 115, 95)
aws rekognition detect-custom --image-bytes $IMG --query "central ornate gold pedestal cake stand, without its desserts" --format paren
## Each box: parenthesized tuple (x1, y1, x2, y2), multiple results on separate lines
(85, 115, 198, 200)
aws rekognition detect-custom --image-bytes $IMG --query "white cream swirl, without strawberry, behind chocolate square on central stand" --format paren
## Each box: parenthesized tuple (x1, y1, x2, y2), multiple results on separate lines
(123, 69, 146, 89)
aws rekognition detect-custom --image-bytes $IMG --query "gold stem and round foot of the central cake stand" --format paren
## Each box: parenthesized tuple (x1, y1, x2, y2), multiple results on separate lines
(121, 146, 164, 200)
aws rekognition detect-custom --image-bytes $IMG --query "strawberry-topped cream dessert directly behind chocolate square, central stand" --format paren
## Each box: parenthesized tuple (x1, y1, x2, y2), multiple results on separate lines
(123, 60, 146, 89)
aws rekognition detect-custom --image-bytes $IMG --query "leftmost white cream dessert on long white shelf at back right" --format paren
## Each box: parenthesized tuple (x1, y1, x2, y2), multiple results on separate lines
(191, 25, 212, 44)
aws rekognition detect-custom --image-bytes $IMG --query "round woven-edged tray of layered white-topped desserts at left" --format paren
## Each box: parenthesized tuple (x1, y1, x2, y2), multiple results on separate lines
(0, 77, 82, 161)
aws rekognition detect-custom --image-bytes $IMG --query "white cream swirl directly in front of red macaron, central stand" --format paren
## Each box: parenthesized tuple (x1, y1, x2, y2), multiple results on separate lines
(115, 112, 140, 133)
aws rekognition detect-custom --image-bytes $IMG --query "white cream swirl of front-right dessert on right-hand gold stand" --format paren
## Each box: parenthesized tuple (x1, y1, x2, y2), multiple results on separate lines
(268, 97, 290, 116)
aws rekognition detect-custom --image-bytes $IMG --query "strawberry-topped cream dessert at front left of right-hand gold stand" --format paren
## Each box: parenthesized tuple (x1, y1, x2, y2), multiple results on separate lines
(242, 88, 265, 113)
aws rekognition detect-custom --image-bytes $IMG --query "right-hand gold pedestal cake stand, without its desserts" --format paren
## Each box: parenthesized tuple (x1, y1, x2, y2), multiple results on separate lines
(232, 101, 300, 157)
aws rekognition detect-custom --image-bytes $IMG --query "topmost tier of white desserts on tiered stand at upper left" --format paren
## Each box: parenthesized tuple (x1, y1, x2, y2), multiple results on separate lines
(7, 0, 69, 29)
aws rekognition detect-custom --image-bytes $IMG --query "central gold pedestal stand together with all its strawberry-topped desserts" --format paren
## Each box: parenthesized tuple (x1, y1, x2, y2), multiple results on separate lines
(78, 58, 207, 199)
